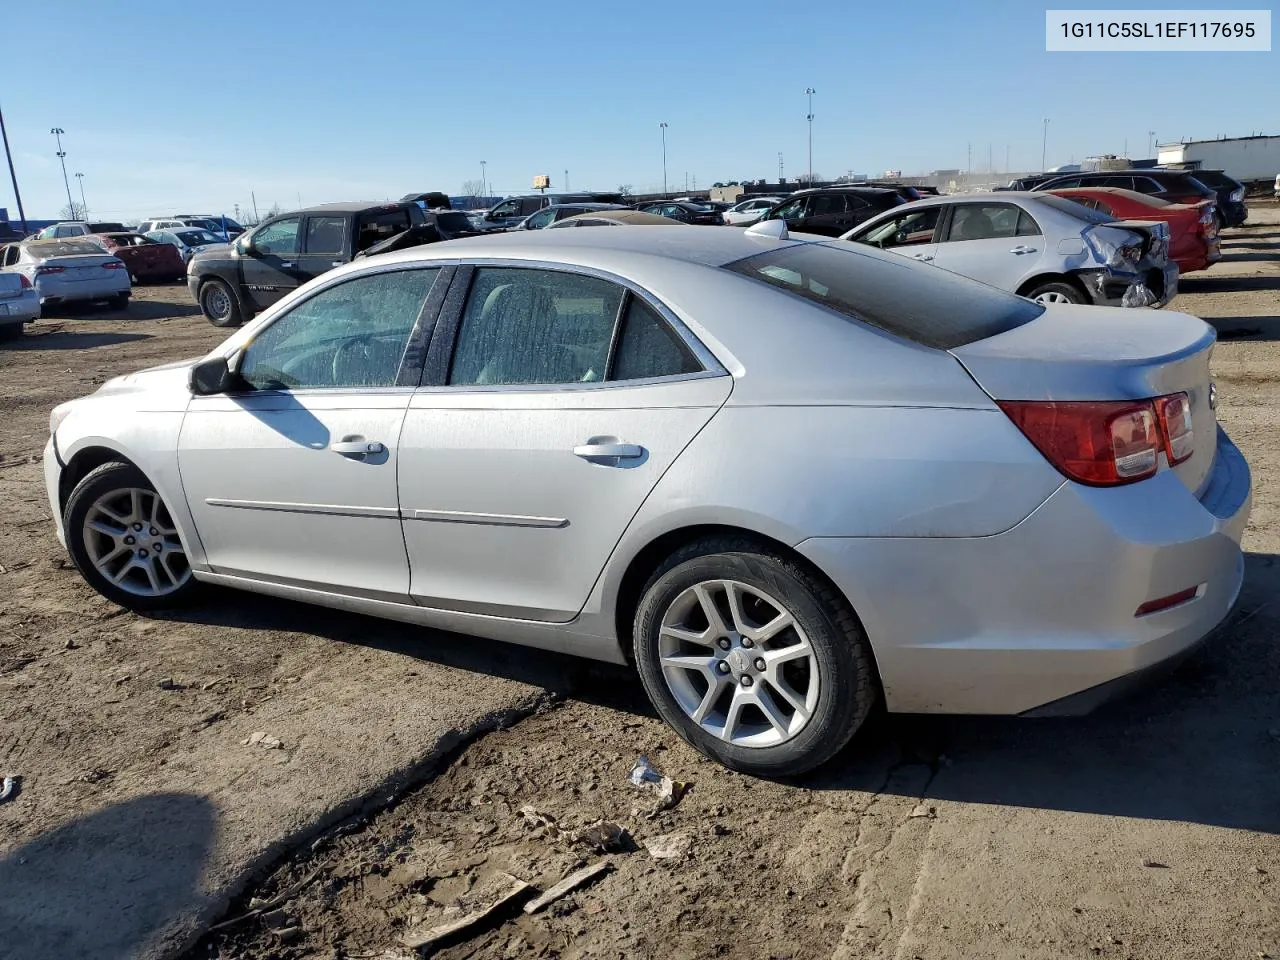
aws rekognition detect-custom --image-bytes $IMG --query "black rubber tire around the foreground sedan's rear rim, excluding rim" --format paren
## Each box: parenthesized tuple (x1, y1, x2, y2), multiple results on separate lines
(634, 550, 876, 777)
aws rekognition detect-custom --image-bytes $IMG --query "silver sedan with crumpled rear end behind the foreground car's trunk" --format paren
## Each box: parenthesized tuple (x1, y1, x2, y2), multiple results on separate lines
(841, 191, 1178, 307)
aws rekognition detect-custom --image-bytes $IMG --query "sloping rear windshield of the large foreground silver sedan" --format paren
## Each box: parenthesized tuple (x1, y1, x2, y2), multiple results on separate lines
(726, 243, 1044, 349)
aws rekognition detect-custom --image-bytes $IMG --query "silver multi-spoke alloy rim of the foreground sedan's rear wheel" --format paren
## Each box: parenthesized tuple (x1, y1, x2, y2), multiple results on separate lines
(658, 580, 820, 748)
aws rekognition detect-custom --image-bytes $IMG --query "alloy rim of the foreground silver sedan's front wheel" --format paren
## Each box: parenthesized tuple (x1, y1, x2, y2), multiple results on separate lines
(81, 486, 191, 596)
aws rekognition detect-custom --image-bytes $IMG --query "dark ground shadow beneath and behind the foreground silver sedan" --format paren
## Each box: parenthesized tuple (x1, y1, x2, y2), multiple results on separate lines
(145, 554, 1280, 833)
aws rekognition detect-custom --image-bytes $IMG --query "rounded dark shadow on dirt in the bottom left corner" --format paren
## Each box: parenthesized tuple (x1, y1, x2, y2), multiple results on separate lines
(0, 794, 216, 960)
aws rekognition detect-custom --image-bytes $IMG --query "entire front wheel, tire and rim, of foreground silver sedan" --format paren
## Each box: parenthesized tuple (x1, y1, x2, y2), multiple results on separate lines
(63, 462, 200, 611)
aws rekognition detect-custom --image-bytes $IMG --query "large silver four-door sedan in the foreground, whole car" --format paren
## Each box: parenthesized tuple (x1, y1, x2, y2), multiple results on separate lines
(44, 221, 1251, 776)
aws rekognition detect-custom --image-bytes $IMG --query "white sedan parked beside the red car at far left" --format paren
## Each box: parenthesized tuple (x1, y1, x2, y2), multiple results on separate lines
(0, 237, 133, 310)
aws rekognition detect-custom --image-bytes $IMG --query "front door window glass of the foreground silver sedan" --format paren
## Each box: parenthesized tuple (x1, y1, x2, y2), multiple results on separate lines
(239, 268, 439, 390)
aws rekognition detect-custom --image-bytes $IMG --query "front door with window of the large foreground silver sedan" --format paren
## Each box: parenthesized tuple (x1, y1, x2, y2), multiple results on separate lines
(178, 268, 448, 593)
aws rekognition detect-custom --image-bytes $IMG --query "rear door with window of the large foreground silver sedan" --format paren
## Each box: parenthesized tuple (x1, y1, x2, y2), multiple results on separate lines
(399, 266, 731, 622)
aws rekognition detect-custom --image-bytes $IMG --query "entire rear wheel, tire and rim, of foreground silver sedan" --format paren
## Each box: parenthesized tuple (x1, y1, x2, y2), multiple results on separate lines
(634, 536, 879, 777)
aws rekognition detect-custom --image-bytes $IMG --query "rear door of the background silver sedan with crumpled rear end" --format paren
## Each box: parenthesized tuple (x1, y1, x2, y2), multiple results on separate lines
(933, 201, 1044, 291)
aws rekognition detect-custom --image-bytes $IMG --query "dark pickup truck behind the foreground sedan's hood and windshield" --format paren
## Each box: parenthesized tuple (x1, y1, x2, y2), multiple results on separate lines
(187, 201, 430, 326)
